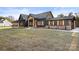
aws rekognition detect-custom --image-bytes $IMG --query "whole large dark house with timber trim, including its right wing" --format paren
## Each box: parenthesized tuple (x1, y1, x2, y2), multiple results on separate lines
(19, 11, 75, 30)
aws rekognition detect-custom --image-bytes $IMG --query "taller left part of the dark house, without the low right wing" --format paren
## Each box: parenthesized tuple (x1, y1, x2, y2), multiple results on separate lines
(19, 11, 53, 27)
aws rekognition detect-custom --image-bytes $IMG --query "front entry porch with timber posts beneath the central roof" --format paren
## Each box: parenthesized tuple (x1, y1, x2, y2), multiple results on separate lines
(28, 17, 45, 28)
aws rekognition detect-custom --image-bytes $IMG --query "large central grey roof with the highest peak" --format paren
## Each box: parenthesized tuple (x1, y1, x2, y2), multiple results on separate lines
(29, 11, 53, 19)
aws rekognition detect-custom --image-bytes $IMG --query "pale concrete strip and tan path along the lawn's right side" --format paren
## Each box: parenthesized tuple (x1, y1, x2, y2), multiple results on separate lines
(57, 28, 79, 51)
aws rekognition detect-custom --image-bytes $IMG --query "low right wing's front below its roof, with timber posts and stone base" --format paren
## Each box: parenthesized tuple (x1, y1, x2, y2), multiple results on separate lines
(48, 20, 75, 30)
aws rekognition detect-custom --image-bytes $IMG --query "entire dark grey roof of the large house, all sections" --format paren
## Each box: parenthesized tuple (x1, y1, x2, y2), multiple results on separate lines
(19, 11, 75, 20)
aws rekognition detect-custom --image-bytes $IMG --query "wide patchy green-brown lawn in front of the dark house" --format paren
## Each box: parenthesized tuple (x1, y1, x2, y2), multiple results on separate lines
(0, 28, 78, 51)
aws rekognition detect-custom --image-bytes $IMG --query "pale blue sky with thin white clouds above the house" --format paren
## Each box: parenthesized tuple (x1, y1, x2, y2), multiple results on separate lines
(0, 7, 79, 19)
